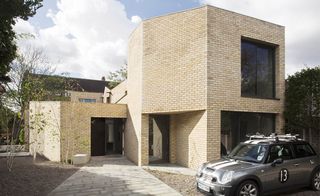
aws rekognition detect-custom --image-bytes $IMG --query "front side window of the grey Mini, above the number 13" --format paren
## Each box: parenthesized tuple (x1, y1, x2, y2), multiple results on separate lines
(267, 144, 293, 163)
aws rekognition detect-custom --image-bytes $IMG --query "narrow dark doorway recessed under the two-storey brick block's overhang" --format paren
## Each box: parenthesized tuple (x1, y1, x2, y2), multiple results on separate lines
(149, 115, 170, 163)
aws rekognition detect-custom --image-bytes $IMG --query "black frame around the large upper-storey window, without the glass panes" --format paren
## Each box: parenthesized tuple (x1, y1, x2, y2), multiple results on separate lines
(240, 37, 277, 99)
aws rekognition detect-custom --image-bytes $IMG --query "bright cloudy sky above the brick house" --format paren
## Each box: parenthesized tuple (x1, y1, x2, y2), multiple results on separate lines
(14, 0, 320, 79)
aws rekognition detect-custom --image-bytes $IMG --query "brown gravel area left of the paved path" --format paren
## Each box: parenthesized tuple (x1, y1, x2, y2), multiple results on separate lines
(0, 157, 79, 196)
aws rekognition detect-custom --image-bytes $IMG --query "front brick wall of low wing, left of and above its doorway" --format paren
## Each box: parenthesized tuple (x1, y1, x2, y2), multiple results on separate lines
(60, 102, 127, 160)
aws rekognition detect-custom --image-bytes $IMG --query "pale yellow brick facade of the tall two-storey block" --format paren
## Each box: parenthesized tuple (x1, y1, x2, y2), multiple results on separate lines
(126, 6, 285, 168)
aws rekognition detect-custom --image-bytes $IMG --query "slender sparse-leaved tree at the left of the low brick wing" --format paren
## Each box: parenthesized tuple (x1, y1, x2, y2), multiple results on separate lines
(1, 47, 74, 170)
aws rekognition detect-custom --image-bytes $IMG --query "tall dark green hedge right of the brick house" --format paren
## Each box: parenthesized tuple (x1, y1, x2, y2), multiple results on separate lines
(284, 66, 320, 147)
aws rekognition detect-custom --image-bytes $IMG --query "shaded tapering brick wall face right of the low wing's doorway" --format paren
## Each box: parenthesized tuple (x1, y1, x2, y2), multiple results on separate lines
(124, 111, 139, 165)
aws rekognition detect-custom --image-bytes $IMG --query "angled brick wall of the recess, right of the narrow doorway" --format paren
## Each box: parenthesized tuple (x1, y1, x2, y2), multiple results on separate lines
(170, 111, 207, 169)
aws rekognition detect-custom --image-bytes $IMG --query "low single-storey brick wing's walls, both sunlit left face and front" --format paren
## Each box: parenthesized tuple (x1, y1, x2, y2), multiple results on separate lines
(29, 101, 127, 161)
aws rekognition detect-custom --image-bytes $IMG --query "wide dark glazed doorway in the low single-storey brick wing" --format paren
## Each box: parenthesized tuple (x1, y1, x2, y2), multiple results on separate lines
(91, 118, 124, 156)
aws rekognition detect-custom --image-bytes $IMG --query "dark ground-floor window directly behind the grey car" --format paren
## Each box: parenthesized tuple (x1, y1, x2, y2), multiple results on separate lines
(221, 111, 275, 152)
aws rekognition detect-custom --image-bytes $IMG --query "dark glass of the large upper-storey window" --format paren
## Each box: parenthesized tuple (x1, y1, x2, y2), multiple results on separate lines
(241, 40, 275, 98)
